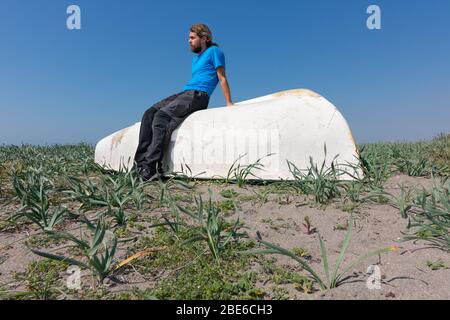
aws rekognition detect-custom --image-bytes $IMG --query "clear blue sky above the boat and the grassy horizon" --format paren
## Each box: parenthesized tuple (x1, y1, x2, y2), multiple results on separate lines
(0, 0, 450, 144)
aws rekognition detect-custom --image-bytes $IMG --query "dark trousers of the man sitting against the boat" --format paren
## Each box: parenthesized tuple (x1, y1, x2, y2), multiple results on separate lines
(134, 90, 209, 172)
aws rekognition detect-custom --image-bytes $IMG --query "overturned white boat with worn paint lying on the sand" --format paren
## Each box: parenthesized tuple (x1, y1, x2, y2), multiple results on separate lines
(95, 89, 361, 180)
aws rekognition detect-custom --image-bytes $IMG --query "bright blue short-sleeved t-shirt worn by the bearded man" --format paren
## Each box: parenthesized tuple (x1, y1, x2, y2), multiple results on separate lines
(183, 46, 225, 96)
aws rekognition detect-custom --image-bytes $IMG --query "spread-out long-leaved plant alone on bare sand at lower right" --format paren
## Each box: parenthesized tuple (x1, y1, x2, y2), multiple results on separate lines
(249, 218, 396, 290)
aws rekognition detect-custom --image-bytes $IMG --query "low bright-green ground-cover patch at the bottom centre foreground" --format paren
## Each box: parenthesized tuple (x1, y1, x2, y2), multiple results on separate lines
(125, 231, 264, 300)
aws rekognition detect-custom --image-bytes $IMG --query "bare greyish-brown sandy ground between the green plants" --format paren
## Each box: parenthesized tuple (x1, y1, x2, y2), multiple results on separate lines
(0, 175, 450, 299)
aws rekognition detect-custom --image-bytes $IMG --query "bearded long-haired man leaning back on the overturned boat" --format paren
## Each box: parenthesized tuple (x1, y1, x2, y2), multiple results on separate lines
(134, 23, 233, 180)
